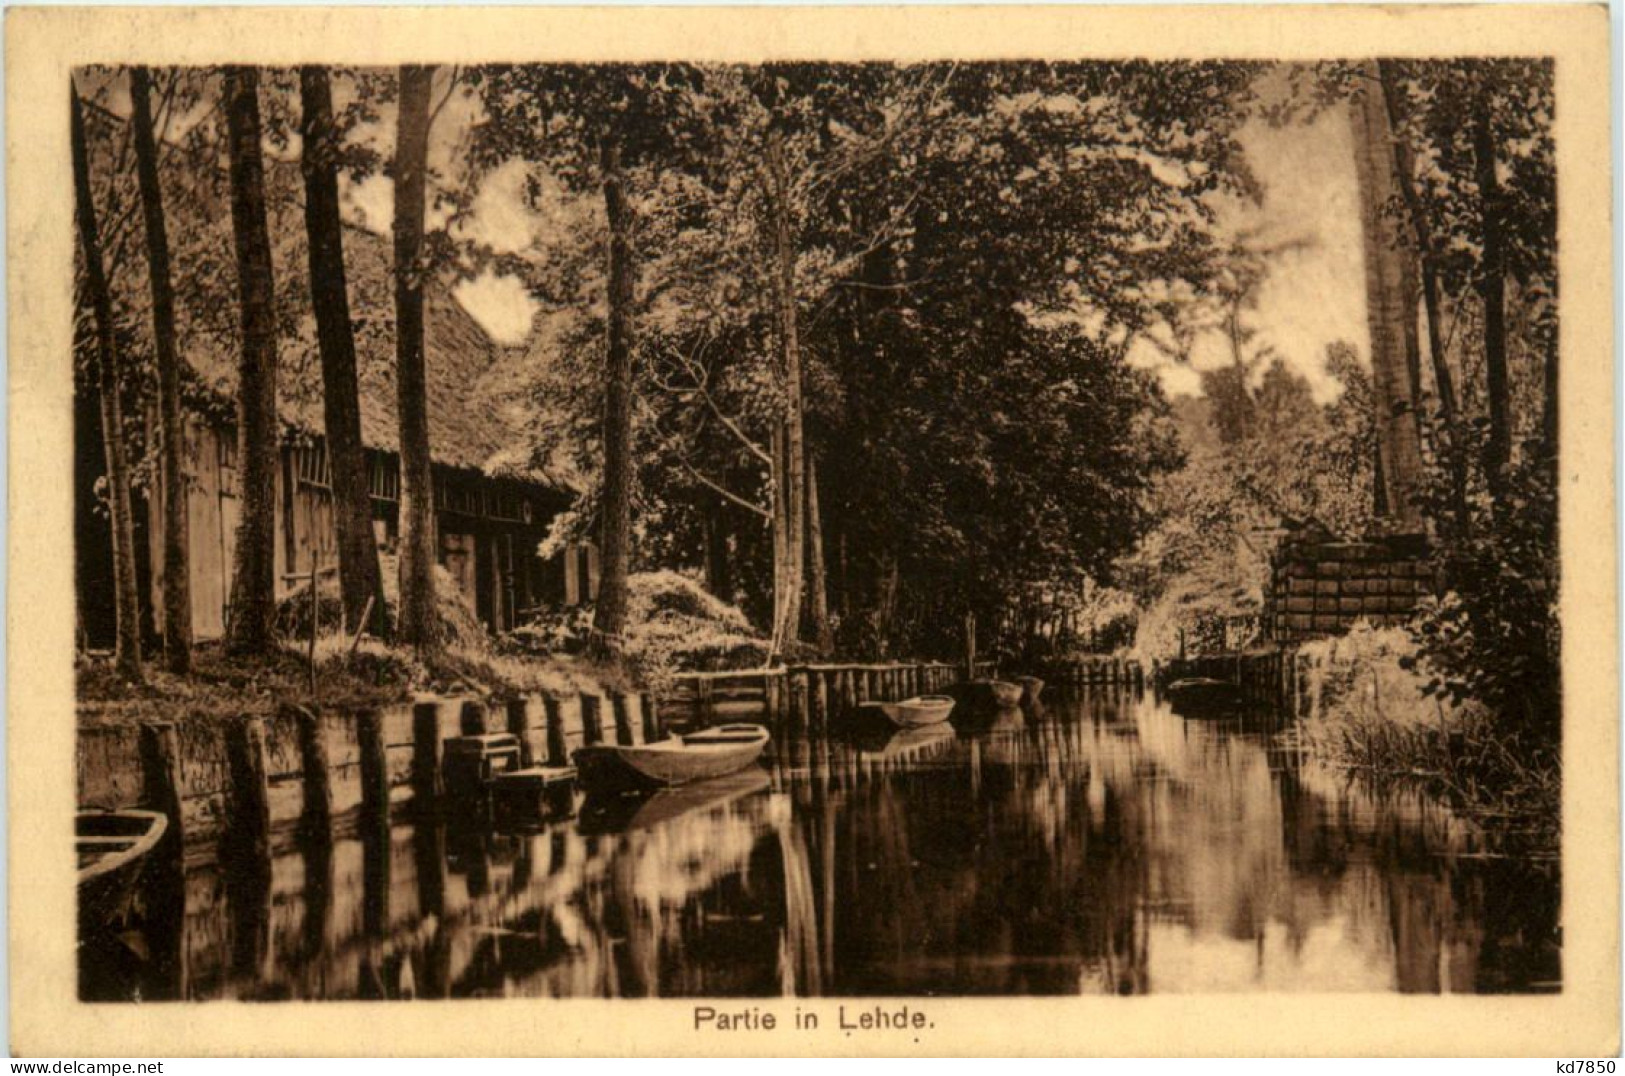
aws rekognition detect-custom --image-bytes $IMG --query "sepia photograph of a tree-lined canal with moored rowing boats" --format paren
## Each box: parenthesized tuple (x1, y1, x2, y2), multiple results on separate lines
(11, 0, 1619, 1048)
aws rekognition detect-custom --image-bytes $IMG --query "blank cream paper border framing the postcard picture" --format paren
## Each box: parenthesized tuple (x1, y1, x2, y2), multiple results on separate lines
(5, 5, 1620, 1056)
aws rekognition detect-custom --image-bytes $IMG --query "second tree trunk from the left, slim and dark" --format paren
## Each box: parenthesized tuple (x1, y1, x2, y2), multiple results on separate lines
(130, 67, 192, 676)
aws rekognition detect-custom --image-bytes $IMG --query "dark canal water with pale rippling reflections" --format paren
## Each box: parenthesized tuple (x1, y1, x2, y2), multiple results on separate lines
(81, 689, 1560, 1000)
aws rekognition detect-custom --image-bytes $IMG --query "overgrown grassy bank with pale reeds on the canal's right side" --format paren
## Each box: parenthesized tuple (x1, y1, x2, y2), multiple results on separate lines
(1282, 624, 1562, 848)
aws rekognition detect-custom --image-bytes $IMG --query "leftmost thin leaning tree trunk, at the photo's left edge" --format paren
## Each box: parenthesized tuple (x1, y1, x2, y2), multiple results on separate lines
(70, 83, 141, 679)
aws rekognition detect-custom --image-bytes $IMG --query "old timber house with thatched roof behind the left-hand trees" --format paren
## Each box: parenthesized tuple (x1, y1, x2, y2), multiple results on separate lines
(75, 101, 596, 644)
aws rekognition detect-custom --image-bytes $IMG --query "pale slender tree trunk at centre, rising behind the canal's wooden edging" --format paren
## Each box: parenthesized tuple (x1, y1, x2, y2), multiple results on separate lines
(767, 135, 806, 645)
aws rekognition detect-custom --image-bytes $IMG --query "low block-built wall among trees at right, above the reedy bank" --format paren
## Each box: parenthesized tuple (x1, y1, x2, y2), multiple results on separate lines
(1264, 535, 1433, 642)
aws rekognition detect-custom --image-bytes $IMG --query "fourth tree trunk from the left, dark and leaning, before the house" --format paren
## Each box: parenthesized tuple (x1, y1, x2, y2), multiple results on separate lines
(299, 67, 385, 634)
